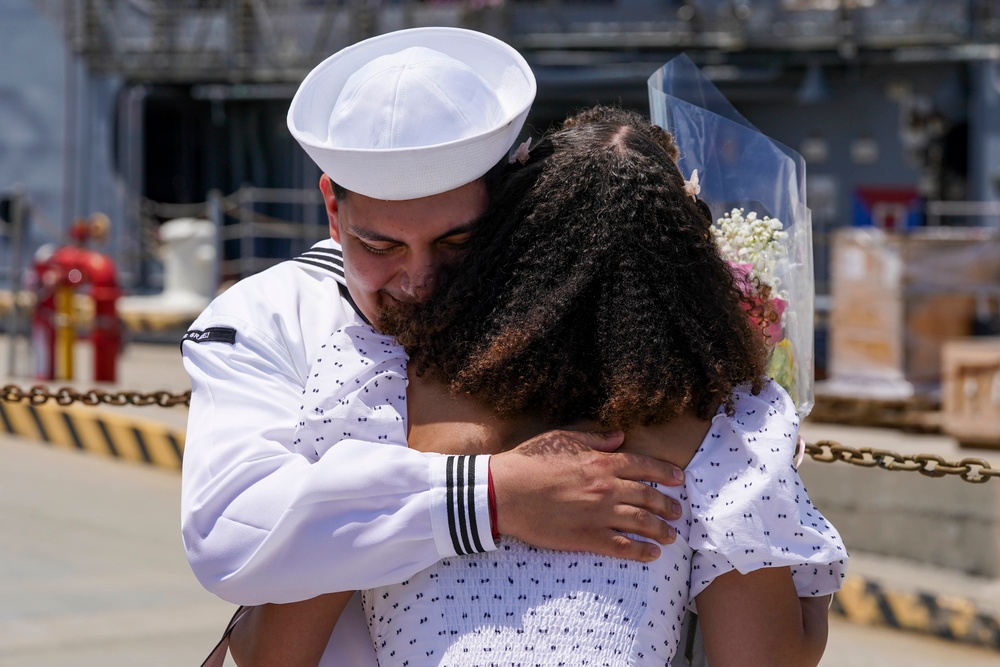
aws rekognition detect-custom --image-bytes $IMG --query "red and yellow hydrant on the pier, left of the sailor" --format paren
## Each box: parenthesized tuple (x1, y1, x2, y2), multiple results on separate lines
(32, 214, 122, 382)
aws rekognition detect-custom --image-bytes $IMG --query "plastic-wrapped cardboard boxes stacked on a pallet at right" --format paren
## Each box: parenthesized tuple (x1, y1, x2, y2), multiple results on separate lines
(828, 227, 1000, 398)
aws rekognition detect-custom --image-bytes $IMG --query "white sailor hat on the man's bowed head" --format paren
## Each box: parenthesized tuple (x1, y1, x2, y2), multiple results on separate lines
(288, 27, 535, 200)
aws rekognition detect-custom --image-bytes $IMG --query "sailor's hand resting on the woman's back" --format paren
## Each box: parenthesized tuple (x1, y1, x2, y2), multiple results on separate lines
(490, 431, 684, 561)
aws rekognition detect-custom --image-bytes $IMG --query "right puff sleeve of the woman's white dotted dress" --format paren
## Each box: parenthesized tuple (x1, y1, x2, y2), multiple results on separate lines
(687, 382, 848, 599)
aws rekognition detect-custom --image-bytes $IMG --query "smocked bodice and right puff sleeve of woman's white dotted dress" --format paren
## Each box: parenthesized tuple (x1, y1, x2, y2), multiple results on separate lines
(363, 383, 847, 667)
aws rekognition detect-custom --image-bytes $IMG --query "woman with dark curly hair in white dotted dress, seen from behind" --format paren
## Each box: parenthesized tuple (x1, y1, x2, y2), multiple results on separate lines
(227, 107, 847, 667)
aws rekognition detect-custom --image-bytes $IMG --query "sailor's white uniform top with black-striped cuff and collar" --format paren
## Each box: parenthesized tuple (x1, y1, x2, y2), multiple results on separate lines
(181, 241, 496, 604)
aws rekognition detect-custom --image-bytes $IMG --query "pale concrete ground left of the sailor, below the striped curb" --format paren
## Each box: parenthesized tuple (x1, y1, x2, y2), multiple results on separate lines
(0, 435, 233, 667)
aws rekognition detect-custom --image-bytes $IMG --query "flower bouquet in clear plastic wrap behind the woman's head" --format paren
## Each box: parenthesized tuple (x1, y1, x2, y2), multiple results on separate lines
(648, 55, 815, 416)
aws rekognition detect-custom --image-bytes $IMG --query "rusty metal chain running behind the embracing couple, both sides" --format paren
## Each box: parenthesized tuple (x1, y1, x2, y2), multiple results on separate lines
(0, 384, 1000, 484)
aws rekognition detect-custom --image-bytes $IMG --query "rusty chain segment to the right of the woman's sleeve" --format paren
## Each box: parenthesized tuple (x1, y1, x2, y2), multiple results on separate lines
(806, 440, 1000, 484)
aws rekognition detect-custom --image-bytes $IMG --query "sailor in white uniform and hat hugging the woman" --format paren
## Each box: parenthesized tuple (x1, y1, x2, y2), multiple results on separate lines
(181, 28, 683, 664)
